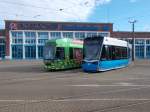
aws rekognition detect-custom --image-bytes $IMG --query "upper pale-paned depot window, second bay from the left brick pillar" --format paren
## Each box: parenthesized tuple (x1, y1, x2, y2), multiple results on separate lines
(25, 32, 36, 44)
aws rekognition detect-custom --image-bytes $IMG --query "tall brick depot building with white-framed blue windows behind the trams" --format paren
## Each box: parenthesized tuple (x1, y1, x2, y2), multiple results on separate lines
(0, 20, 113, 59)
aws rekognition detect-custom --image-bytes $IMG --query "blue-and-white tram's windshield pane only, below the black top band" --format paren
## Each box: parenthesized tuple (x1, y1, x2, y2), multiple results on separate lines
(84, 41, 100, 60)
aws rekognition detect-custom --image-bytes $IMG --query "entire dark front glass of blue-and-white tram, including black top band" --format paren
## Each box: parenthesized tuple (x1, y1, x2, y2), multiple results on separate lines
(84, 39, 103, 60)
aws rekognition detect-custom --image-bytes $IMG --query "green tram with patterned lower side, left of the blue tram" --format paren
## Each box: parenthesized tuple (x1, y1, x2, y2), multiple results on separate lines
(43, 38, 83, 71)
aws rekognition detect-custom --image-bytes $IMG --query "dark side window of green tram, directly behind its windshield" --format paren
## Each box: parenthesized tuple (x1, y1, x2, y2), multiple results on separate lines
(56, 47, 65, 59)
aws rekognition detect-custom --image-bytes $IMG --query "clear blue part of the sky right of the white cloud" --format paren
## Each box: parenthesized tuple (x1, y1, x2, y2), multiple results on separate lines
(89, 0, 150, 31)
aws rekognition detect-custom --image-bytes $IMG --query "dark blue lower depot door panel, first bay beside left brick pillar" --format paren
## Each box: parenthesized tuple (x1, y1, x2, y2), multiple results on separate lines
(12, 45, 23, 59)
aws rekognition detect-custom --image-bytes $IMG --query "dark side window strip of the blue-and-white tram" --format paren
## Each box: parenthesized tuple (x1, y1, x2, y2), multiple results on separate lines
(101, 45, 128, 60)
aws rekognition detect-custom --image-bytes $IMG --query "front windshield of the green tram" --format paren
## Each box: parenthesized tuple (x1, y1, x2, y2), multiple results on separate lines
(44, 45, 56, 60)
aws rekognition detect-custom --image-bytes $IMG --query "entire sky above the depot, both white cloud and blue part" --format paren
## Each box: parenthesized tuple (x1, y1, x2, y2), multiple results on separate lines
(0, 0, 150, 31)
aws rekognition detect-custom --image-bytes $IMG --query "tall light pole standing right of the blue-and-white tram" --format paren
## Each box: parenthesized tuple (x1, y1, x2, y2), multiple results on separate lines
(129, 20, 137, 61)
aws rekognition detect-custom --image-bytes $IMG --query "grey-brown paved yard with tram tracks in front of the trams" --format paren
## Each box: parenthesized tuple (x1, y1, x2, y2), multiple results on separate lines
(0, 60, 150, 112)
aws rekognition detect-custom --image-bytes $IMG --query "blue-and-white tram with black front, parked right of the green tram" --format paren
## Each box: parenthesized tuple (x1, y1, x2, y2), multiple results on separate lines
(82, 36, 132, 72)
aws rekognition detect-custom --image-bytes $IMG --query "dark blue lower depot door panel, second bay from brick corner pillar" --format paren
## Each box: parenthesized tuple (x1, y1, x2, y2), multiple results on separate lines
(25, 46, 36, 59)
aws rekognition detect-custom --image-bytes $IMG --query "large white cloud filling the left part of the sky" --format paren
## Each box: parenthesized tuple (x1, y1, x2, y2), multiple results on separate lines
(0, 0, 111, 21)
